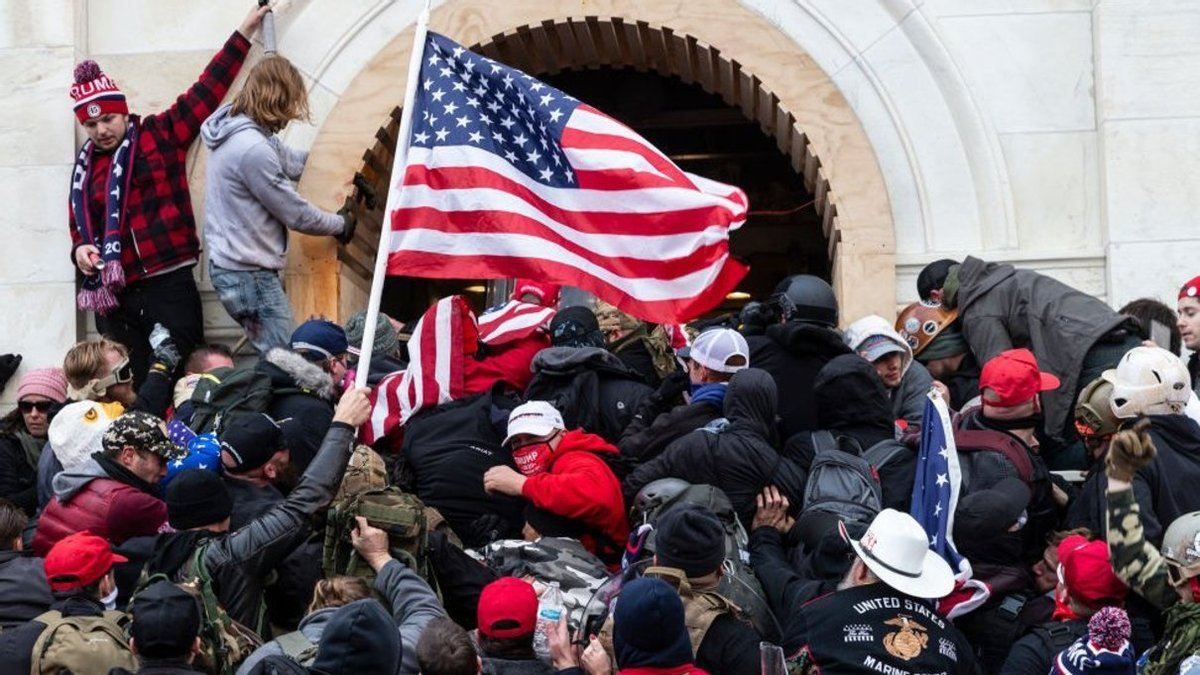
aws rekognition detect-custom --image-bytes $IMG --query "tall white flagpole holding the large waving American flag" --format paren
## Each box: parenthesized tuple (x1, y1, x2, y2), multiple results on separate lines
(354, 0, 430, 387)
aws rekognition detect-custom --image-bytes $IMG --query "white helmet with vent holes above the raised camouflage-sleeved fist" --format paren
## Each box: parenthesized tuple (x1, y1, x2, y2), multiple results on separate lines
(1102, 347, 1192, 419)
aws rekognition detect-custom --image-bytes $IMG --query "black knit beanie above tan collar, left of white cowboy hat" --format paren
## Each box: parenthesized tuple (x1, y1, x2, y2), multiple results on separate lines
(654, 504, 725, 578)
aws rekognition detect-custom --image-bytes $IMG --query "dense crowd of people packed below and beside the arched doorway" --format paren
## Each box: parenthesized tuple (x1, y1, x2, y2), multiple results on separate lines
(7, 2, 1200, 675)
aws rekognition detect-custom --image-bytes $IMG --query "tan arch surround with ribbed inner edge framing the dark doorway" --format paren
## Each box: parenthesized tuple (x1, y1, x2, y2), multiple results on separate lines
(288, 0, 895, 317)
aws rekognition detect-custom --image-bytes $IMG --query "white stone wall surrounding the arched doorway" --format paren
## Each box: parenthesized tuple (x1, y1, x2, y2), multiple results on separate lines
(0, 0, 1200, 398)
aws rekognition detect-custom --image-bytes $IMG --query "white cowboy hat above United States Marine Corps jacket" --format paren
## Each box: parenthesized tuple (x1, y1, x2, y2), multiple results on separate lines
(838, 508, 954, 598)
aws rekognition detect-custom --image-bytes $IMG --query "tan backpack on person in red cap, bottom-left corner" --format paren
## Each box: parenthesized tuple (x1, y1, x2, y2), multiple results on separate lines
(30, 610, 138, 675)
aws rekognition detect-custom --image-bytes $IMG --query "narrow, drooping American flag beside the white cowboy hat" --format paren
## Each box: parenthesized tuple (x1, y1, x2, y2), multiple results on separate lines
(911, 392, 991, 619)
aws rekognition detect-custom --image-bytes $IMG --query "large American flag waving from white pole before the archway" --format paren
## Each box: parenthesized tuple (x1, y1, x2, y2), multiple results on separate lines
(388, 32, 746, 323)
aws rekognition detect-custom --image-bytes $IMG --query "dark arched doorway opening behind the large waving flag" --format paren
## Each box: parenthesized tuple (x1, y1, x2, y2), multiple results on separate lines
(383, 67, 830, 321)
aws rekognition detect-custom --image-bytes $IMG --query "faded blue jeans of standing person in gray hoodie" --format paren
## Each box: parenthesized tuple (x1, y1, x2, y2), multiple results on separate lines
(209, 262, 294, 354)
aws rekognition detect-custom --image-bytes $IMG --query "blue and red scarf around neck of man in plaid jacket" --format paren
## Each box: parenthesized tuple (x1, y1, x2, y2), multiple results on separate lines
(71, 119, 138, 315)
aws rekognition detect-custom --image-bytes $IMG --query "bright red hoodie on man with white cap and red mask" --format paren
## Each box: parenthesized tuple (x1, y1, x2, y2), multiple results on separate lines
(521, 429, 629, 548)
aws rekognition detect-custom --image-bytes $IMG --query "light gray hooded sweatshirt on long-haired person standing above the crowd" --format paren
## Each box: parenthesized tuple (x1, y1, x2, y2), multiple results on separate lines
(200, 103, 346, 271)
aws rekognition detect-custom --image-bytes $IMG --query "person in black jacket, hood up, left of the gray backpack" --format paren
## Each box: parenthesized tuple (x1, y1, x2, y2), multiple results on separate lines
(625, 365, 806, 524)
